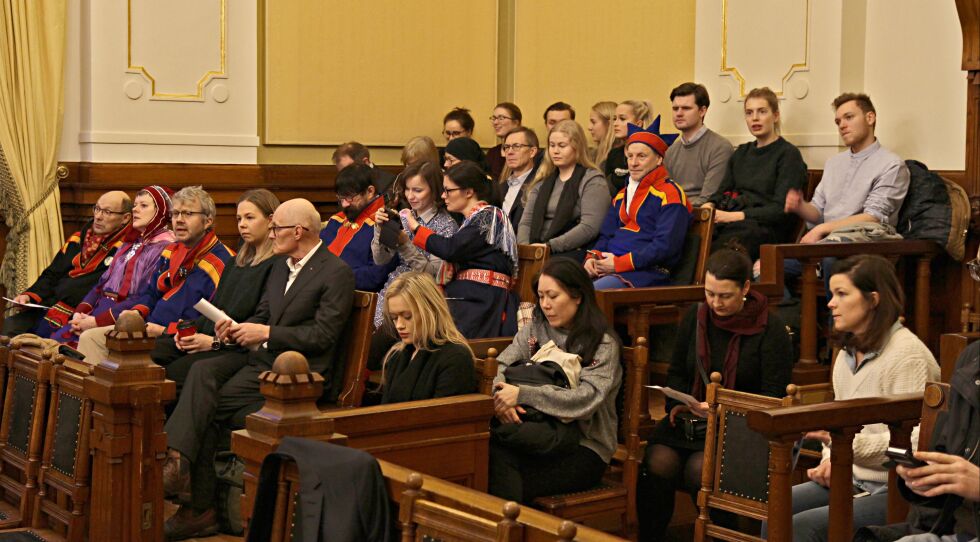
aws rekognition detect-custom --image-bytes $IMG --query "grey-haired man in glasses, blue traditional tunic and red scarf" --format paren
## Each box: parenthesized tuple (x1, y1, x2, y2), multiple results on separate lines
(78, 186, 231, 363)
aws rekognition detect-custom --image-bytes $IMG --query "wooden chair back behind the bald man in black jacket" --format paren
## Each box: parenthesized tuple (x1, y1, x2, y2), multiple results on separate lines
(337, 290, 378, 408)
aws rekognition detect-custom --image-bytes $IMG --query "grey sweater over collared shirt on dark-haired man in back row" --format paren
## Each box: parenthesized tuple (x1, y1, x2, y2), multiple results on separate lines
(664, 129, 734, 205)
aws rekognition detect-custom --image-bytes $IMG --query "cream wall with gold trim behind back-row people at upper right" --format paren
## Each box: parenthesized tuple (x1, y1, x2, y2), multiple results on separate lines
(695, 0, 966, 169)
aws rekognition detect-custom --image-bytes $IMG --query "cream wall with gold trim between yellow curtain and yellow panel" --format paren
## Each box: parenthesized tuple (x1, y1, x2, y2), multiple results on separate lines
(59, 0, 259, 163)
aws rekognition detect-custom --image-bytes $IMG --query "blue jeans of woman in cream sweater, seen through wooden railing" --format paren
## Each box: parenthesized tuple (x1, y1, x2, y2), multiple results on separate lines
(762, 480, 888, 542)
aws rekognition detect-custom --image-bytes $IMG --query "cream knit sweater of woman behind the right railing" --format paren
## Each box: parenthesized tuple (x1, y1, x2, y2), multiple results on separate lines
(823, 325, 939, 482)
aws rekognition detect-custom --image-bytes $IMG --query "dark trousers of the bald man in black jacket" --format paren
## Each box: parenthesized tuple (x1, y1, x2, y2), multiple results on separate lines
(164, 352, 269, 511)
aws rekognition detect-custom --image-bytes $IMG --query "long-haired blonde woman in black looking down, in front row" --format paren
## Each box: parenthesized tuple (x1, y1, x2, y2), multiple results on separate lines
(381, 271, 476, 404)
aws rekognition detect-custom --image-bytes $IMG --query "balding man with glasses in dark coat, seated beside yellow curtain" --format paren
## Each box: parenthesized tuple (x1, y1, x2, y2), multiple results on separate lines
(2, 191, 133, 336)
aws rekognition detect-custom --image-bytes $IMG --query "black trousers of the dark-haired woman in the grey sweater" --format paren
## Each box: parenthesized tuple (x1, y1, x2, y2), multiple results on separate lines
(489, 441, 606, 504)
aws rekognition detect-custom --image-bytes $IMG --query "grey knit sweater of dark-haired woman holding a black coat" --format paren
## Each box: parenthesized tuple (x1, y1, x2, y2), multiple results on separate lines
(494, 317, 623, 463)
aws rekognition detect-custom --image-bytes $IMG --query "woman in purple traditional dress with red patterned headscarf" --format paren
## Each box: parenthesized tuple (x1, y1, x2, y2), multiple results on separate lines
(44, 185, 176, 344)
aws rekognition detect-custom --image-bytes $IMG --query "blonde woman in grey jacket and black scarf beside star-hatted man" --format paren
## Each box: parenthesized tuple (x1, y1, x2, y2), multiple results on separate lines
(517, 120, 612, 262)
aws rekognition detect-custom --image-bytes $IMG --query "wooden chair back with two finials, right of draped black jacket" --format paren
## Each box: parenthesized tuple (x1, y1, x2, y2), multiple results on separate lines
(398, 472, 524, 542)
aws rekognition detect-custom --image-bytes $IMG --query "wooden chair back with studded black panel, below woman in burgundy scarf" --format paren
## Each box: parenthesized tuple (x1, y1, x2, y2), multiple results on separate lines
(694, 373, 793, 541)
